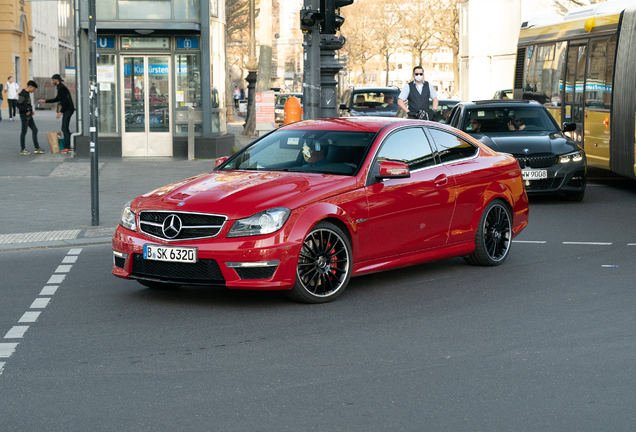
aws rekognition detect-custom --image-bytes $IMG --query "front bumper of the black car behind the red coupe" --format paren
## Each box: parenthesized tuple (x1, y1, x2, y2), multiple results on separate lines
(523, 159, 587, 194)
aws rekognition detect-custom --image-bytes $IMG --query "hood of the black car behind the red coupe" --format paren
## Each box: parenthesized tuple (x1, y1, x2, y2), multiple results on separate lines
(473, 132, 578, 155)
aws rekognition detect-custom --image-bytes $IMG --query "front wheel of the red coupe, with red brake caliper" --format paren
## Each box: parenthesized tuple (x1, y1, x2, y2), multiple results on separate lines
(287, 222, 352, 303)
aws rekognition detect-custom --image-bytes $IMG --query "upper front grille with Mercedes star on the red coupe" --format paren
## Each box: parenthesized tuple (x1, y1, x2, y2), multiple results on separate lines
(139, 210, 227, 241)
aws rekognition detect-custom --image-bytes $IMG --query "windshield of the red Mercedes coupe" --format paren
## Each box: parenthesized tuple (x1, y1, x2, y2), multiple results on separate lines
(219, 129, 376, 175)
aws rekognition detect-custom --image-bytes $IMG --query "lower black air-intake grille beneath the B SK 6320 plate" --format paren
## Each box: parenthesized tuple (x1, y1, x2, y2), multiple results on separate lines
(131, 254, 225, 284)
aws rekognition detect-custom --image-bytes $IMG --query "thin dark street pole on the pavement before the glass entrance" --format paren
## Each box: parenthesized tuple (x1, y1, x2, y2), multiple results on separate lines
(88, 0, 99, 226)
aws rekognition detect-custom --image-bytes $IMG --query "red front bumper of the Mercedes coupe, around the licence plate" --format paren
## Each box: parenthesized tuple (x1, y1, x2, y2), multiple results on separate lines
(112, 226, 302, 290)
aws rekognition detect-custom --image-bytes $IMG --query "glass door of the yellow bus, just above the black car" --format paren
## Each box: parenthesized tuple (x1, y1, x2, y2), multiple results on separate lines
(561, 43, 587, 147)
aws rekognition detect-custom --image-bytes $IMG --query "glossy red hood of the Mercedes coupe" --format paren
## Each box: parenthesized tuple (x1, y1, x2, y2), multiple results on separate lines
(132, 171, 356, 219)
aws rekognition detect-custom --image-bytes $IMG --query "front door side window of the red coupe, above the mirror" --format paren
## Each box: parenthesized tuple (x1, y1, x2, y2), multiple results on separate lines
(378, 127, 435, 171)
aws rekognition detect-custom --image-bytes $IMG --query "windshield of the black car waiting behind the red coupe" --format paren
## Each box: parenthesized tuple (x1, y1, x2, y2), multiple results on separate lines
(461, 106, 559, 133)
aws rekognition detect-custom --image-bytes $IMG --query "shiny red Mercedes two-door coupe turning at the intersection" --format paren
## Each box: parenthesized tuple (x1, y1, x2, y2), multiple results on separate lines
(112, 117, 528, 303)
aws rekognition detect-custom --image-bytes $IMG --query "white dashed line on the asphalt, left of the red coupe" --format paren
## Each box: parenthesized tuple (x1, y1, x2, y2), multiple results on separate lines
(0, 248, 82, 375)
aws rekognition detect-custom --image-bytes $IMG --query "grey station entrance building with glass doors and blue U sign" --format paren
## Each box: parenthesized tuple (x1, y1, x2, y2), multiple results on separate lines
(76, 0, 234, 158)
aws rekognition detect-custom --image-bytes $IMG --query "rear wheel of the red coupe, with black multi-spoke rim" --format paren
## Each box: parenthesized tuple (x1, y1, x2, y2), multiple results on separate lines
(465, 200, 512, 266)
